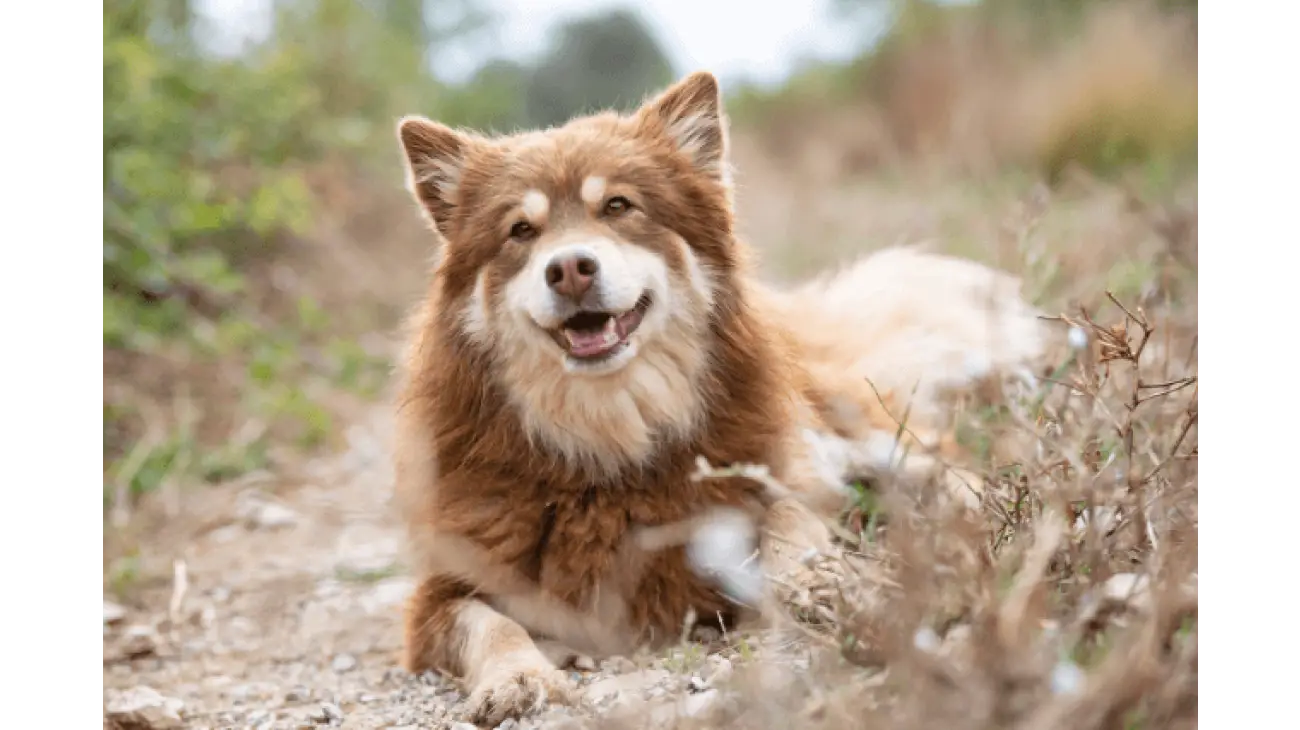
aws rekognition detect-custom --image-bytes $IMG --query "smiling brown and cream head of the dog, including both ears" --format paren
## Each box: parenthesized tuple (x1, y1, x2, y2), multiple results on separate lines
(399, 73, 733, 378)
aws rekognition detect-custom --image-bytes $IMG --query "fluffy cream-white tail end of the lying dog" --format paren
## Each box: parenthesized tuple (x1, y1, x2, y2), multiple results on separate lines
(777, 247, 1048, 416)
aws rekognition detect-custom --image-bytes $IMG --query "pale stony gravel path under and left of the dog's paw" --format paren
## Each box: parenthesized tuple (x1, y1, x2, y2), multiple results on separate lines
(96, 409, 748, 730)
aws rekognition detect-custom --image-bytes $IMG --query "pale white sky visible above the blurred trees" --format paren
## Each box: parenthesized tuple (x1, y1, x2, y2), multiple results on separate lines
(196, 0, 870, 86)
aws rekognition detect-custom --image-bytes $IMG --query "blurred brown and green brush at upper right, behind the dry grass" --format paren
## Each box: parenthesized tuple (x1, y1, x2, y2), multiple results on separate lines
(733, 0, 1200, 179)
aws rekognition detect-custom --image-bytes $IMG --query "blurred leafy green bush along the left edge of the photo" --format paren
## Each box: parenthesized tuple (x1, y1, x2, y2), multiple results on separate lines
(98, 0, 438, 490)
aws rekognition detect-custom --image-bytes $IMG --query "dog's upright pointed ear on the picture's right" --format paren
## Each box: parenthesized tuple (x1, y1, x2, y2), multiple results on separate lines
(637, 71, 731, 187)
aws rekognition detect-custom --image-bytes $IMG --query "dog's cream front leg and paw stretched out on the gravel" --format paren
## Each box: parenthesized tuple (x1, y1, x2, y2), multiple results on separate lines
(404, 577, 576, 727)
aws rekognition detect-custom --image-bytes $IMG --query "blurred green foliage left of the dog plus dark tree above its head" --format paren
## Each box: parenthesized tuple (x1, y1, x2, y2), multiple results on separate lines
(96, 0, 672, 492)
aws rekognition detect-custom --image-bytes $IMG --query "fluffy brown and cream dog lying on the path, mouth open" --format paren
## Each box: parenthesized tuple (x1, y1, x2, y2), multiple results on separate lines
(394, 71, 1043, 725)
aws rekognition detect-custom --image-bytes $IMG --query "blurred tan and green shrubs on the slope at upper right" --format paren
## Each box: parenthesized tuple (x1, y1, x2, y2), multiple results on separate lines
(755, 0, 1200, 179)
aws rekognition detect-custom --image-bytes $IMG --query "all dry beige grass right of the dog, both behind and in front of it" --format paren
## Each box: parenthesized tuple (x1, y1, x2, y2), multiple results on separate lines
(582, 105, 1200, 730)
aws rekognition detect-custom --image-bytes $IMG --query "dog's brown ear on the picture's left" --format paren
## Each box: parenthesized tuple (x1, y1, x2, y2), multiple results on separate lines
(398, 116, 473, 236)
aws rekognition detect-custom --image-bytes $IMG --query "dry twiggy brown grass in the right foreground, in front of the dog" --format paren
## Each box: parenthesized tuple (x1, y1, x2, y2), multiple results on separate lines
(590, 275, 1200, 730)
